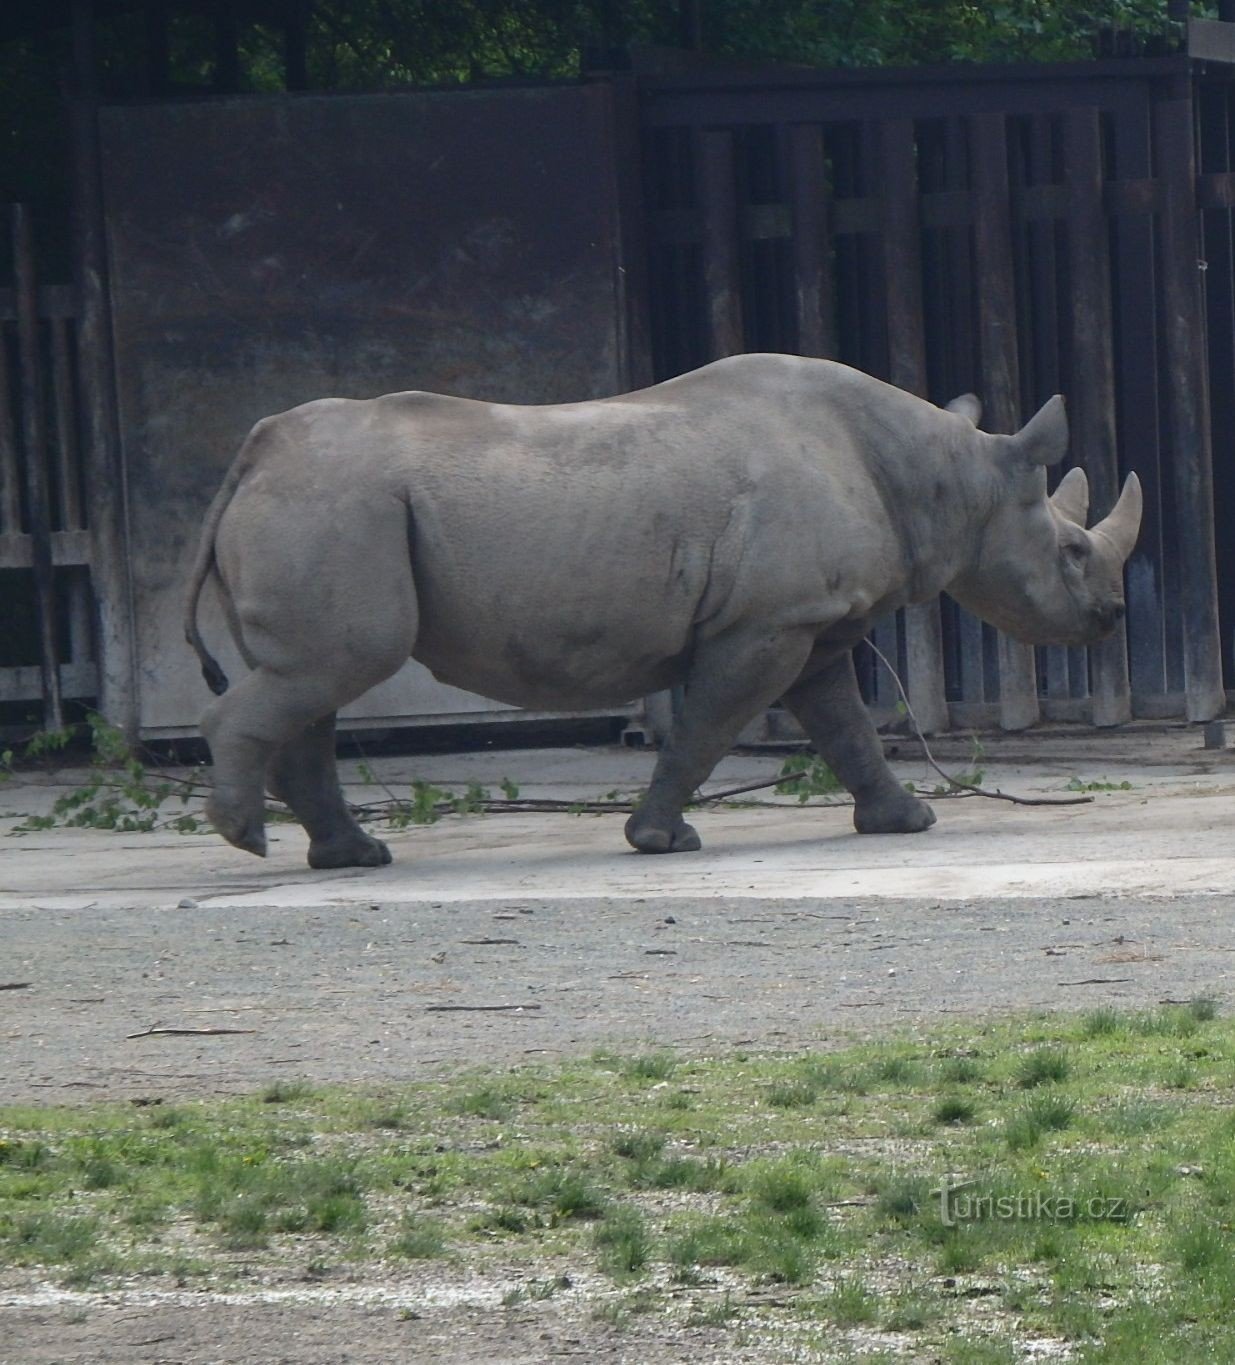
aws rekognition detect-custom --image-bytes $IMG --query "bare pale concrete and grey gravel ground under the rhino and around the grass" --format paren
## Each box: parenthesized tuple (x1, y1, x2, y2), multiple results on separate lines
(0, 726, 1235, 1365)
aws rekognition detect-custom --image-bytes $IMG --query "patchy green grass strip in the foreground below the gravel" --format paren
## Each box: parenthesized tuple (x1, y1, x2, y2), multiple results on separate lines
(0, 1001, 1235, 1365)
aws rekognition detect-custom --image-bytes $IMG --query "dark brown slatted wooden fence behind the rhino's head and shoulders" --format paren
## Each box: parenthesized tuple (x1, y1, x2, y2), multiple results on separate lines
(643, 59, 1235, 729)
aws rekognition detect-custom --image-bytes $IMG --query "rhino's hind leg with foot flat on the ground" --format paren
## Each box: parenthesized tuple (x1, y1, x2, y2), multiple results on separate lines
(266, 711, 390, 868)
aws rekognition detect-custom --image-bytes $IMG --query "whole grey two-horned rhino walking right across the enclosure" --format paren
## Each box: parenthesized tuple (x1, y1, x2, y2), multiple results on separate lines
(186, 355, 1141, 868)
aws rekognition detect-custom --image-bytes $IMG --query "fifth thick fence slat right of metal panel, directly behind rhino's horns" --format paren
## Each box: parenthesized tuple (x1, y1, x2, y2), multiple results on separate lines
(1064, 109, 1133, 725)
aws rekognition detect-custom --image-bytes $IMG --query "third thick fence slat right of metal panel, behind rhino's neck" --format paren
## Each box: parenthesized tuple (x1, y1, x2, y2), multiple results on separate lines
(879, 119, 948, 734)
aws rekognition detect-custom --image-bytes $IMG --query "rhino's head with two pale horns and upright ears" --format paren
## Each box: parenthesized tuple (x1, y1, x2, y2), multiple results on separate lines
(948, 396, 1141, 644)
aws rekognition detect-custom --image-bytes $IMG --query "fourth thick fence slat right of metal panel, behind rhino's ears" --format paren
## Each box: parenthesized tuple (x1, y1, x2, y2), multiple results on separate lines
(972, 113, 1040, 730)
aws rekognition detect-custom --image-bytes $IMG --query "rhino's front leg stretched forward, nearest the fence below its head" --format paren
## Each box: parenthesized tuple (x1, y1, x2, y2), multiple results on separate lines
(783, 650, 935, 834)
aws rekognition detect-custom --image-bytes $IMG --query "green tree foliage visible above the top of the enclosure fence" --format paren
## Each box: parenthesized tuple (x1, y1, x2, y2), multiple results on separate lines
(81, 0, 1189, 91)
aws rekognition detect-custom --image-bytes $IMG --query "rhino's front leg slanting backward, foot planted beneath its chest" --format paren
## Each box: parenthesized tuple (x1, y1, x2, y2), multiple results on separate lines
(626, 629, 811, 853)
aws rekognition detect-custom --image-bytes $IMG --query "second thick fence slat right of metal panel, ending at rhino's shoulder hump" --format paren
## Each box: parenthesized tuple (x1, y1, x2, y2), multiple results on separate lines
(789, 123, 837, 359)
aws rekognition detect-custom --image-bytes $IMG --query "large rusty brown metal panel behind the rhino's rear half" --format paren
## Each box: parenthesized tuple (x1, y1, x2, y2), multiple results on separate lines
(100, 85, 628, 736)
